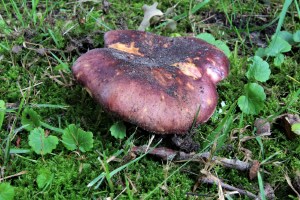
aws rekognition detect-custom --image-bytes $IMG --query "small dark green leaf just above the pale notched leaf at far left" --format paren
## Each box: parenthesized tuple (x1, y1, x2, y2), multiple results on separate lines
(21, 108, 41, 131)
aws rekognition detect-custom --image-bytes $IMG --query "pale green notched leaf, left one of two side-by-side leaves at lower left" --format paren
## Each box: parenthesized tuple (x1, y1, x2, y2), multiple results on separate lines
(28, 128, 58, 155)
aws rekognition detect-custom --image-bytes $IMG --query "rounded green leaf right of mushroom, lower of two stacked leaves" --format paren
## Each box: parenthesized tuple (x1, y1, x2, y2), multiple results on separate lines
(238, 83, 266, 115)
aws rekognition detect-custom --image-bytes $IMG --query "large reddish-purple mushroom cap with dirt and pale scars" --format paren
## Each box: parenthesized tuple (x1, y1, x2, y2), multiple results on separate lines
(72, 30, 229, 135)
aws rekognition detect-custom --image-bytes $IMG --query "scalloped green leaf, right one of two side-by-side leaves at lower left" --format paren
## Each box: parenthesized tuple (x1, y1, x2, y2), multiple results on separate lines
(62, 124, 94, 152)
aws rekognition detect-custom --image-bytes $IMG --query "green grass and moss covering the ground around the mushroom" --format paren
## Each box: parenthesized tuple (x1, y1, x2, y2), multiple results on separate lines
(0, 0, 300, 199)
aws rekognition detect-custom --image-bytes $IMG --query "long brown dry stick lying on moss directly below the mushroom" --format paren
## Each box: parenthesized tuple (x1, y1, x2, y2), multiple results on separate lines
(132, 145, 252, 171)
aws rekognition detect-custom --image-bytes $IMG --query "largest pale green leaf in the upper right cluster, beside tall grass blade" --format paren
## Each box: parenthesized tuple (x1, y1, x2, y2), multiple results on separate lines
(265, 37, 292, 56)
